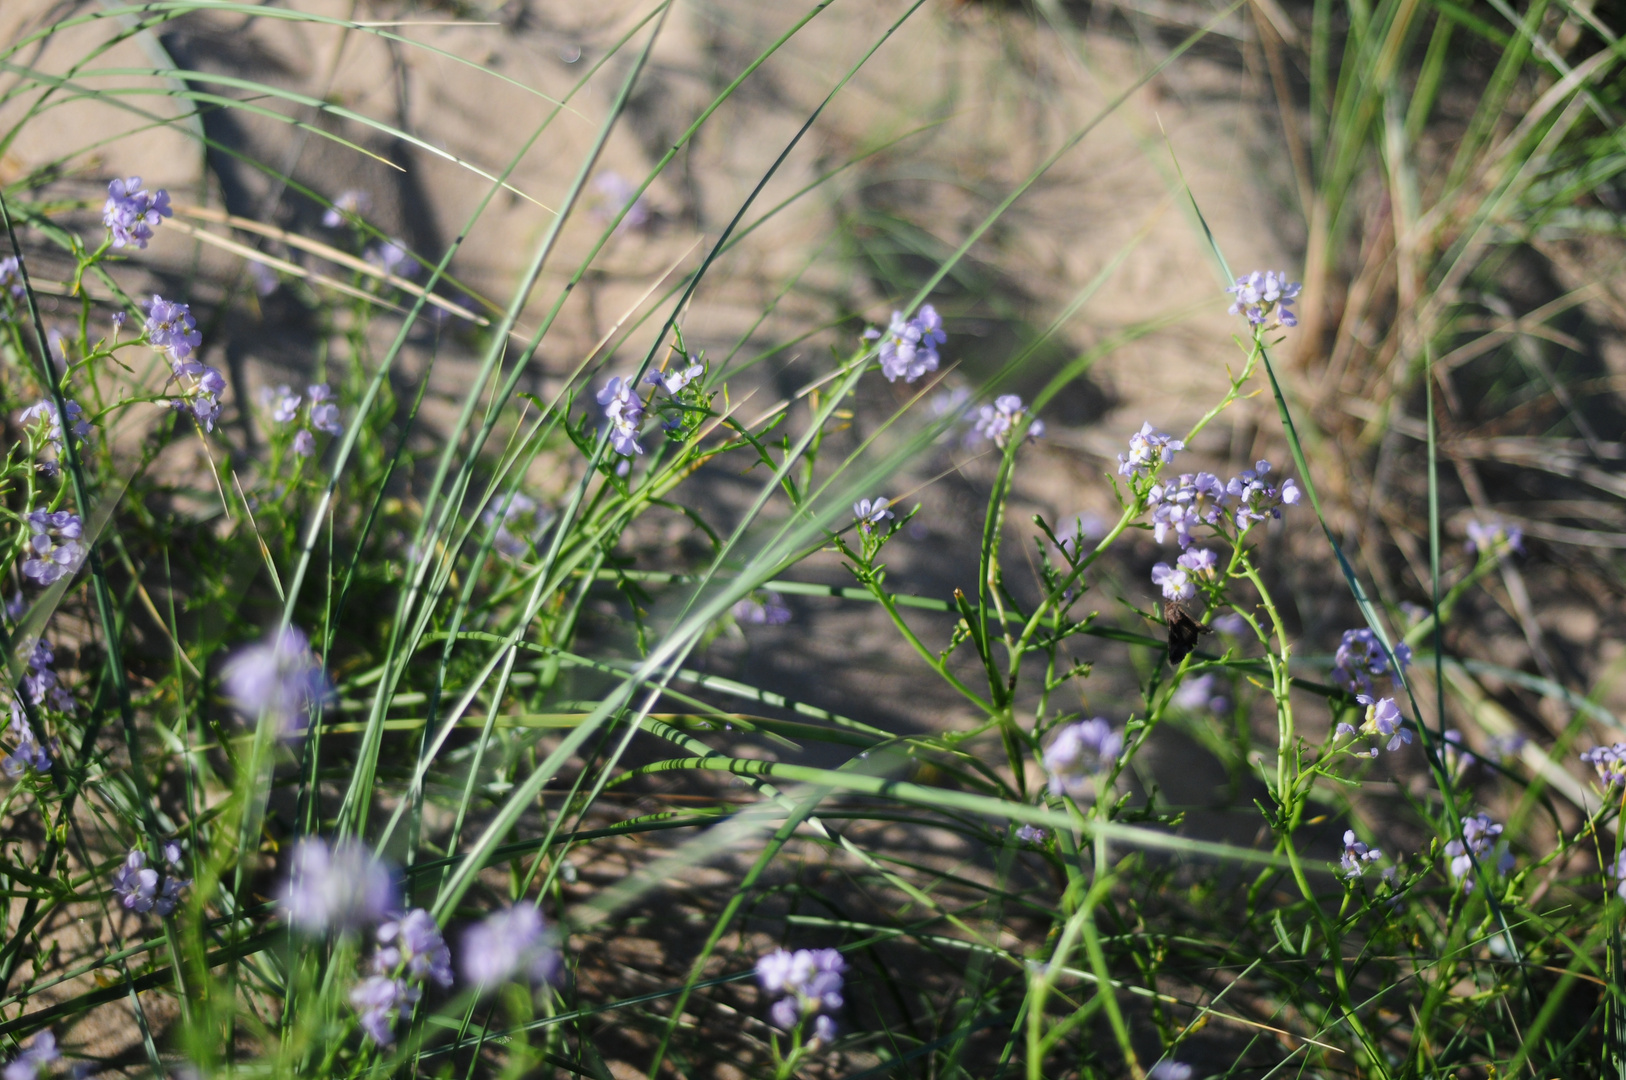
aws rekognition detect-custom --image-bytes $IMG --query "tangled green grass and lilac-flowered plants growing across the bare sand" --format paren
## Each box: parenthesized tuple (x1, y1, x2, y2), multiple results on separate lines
(0, 0, 1626, 1080)
